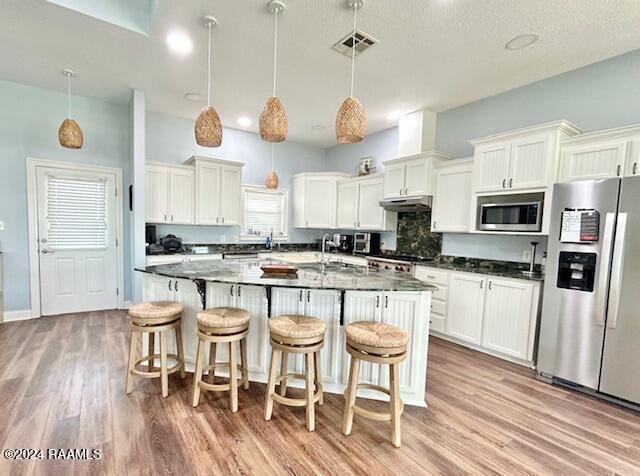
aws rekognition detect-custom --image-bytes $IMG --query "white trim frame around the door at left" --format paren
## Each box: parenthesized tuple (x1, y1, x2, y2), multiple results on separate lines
(26, 157, 125, 318)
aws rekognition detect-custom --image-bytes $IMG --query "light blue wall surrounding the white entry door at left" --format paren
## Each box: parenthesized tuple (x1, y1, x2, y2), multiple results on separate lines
(0, 81, 131, 311)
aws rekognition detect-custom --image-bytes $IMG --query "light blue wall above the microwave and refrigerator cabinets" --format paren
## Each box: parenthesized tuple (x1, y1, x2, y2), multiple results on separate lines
(436, 50, 640, 158)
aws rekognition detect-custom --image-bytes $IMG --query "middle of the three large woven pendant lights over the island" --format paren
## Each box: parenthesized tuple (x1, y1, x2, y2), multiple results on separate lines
(259, 0, 289, 142)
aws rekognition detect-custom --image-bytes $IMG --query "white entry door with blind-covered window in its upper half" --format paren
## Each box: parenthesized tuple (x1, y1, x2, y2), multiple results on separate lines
(36, 167, 118, 316)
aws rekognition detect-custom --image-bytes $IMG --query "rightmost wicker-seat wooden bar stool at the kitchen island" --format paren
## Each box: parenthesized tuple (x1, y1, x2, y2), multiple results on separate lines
(342, 321, 409, 448)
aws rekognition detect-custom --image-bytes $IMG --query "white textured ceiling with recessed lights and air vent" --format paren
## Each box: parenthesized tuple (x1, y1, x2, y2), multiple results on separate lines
(0, 0, 640, 147)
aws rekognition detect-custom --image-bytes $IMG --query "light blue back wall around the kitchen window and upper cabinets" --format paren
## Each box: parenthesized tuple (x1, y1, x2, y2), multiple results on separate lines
(146, 112, 327, 243)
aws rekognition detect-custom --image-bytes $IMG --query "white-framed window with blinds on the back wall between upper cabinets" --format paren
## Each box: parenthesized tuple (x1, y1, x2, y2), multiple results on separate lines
(241, 186, 289, 240)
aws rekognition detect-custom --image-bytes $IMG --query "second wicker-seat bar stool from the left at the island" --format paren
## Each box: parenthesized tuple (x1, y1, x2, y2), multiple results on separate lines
(193, 307, 251, 412)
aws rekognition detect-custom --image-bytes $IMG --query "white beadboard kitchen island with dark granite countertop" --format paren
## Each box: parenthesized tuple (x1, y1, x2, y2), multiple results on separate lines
(137, 259, 437, 406)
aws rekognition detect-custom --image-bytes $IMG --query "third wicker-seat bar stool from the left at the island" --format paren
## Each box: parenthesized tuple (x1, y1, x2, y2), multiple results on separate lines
(264, 315, 327, 431)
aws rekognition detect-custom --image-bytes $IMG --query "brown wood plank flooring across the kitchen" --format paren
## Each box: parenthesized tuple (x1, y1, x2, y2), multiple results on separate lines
(0, 311, 640, 476)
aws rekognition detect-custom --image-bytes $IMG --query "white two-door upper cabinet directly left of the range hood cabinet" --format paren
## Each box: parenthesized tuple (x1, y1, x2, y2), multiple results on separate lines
(336, 174, 397, 230)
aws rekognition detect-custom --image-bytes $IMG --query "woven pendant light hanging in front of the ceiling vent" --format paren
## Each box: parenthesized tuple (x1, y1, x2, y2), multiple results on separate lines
(336, 0, 367, 144)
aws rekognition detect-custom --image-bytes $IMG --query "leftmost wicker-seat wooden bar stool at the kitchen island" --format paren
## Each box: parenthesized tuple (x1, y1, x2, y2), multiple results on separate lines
(127, 301, 185, 397)
